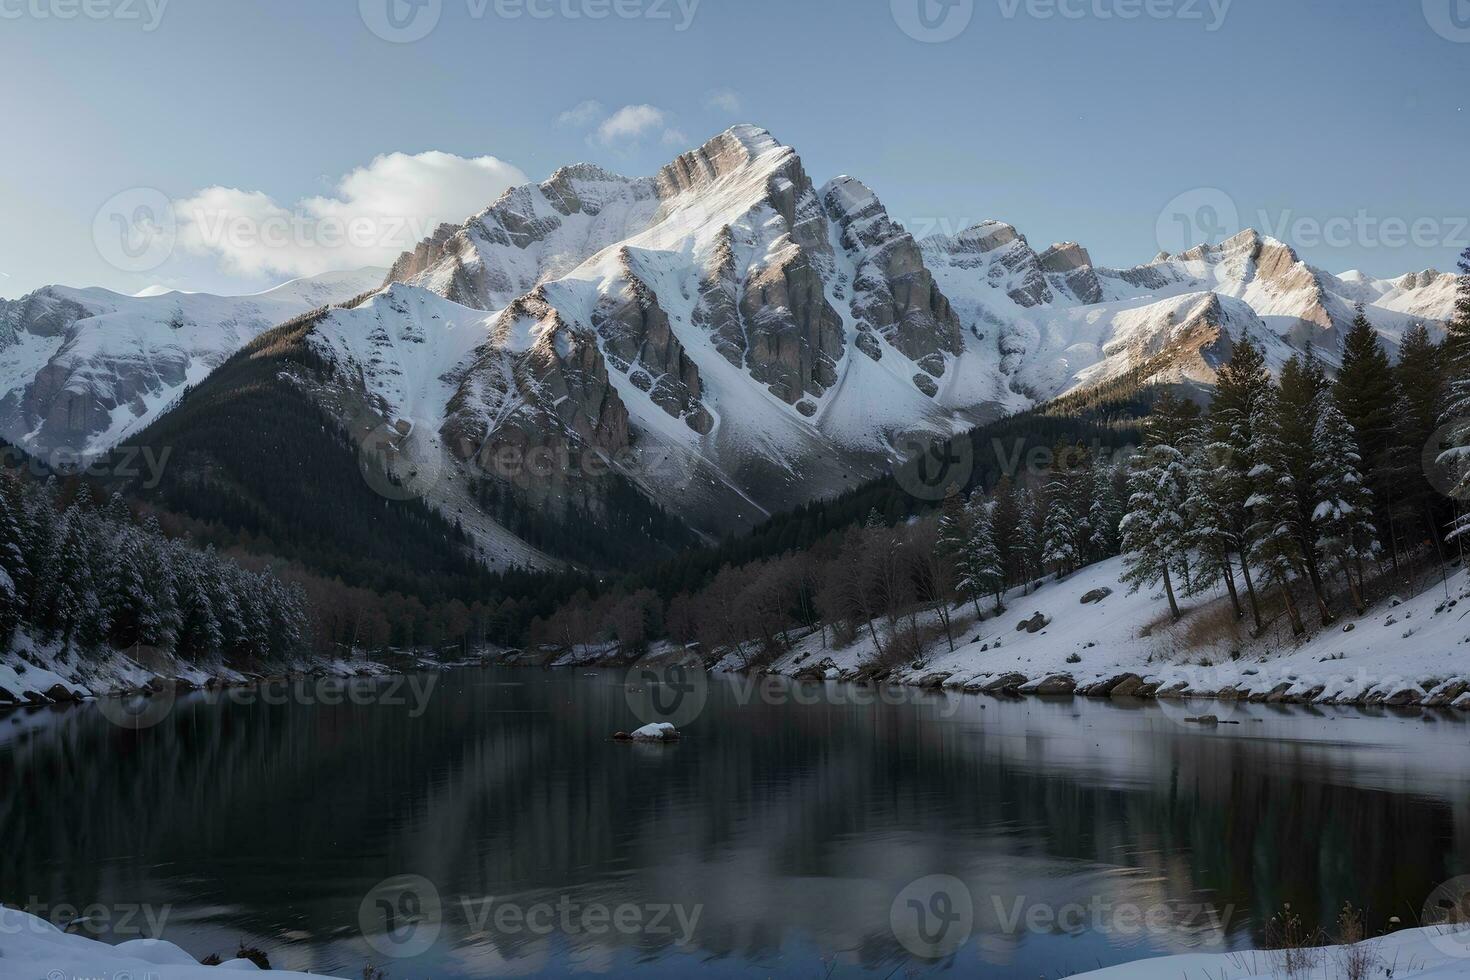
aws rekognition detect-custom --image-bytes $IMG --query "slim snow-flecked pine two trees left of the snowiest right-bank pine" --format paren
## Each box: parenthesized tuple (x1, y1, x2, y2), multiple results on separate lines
(1247, 388, 1307, 636)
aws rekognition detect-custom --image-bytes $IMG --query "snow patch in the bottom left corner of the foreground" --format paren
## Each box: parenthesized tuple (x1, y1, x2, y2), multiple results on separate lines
(0, 907, 336, 980)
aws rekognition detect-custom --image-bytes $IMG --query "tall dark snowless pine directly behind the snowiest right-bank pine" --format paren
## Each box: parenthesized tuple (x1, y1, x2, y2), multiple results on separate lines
(1333, 306, 1399, 566)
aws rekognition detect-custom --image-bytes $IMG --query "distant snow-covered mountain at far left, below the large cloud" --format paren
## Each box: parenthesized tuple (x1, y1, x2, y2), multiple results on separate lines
(0, 269, 382, 455)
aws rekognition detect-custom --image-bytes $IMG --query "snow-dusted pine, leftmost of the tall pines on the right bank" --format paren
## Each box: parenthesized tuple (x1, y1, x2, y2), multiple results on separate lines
(1120, 413, 1188, 621)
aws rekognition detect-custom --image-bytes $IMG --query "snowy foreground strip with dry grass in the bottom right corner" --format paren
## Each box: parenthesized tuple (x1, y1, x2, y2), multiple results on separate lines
(1082, 929, 1470, 980)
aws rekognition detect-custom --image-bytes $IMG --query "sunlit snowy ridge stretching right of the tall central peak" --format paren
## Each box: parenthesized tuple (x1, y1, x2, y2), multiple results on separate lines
(922, 222, 1457, 401)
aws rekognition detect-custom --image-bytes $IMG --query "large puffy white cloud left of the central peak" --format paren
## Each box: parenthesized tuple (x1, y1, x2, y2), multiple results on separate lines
(173, 150, 528, 278)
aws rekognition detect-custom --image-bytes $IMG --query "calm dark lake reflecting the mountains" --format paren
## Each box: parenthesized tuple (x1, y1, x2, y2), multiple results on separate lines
(0, 669, 1470, 980)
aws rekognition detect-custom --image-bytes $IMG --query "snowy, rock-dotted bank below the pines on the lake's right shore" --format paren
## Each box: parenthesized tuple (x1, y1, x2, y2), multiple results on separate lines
(764, 558, 1470, 708)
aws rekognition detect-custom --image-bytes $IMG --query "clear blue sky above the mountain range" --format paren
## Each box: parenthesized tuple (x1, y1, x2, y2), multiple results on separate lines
(0, 0, 1470, 297)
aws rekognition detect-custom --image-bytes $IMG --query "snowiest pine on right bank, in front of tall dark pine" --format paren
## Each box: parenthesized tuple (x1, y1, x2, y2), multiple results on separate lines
(1311, 392, 1380, 616)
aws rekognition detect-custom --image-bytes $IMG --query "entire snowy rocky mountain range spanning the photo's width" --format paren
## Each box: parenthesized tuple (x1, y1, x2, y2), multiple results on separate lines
(0, 126, 1455, 564)
